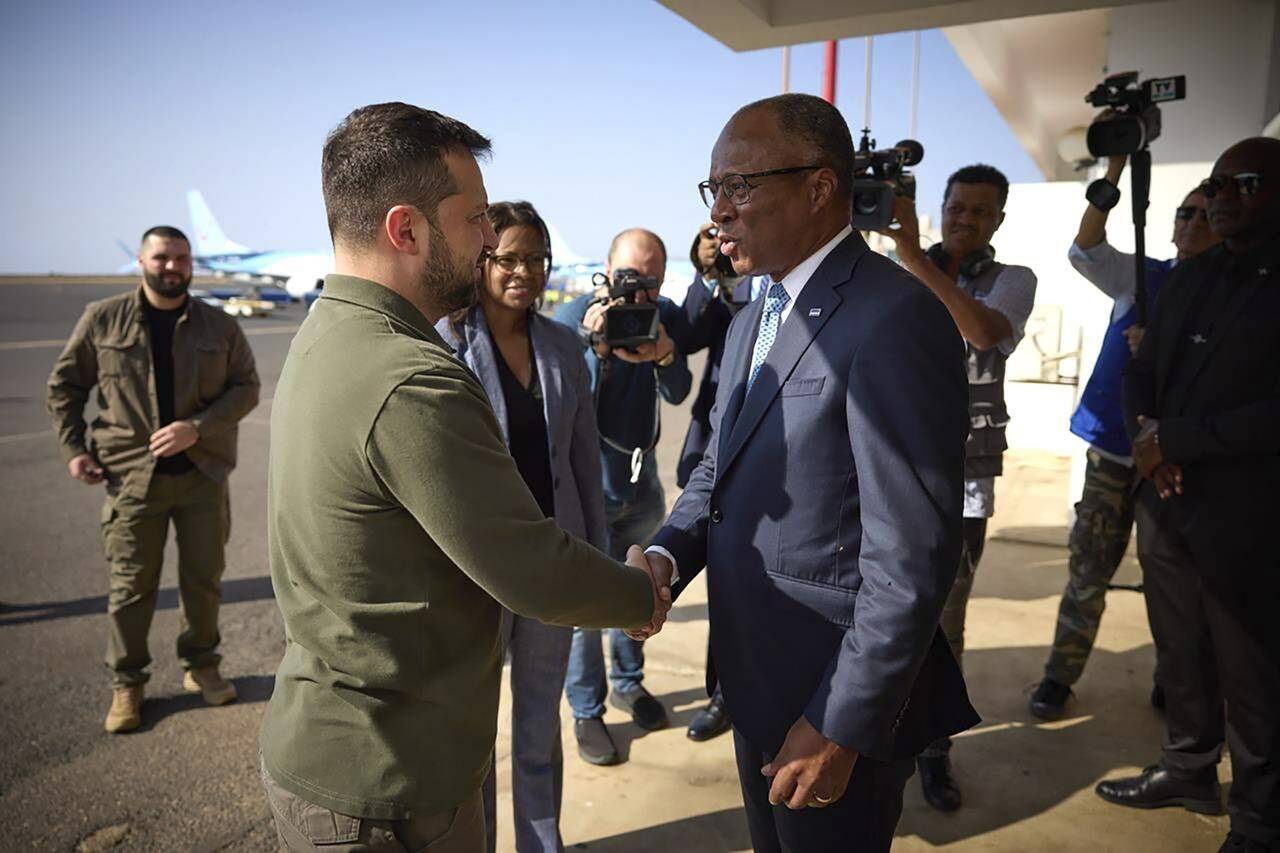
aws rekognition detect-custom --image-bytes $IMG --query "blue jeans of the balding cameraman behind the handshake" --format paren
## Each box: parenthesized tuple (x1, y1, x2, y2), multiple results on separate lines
(564, 478, 667, 720)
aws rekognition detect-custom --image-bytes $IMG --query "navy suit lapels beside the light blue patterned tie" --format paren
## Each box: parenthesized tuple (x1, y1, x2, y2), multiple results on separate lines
(717, 232, 867, 471)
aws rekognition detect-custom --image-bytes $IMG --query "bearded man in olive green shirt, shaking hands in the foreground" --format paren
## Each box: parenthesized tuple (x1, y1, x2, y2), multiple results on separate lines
(260, 104, 671, 850)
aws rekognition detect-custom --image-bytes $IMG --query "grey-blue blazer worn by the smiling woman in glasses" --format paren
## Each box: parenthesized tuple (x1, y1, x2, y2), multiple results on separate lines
(435, 305, 608, 552)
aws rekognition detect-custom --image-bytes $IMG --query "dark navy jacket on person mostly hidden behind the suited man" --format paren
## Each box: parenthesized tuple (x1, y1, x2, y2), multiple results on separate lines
(667, 275, 751, 488)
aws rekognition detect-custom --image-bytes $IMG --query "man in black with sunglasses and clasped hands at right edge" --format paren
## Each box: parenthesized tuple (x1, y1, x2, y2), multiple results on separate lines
(1097, 137, 1280, 852)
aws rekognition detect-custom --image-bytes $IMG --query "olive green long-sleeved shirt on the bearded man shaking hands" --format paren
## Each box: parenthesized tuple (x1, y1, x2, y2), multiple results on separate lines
(260, 275, 653, 820)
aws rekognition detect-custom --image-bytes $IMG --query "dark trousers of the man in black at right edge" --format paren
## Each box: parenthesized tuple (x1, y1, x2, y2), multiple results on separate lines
(1137, 487, 1280, 841)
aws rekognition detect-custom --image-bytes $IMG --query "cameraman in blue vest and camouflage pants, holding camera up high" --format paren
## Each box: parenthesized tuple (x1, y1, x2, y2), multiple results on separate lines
(1030, 156, 1220, 720)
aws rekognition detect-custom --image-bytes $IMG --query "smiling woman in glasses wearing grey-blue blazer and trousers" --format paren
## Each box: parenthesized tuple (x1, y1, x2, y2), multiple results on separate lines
(436, 201, 607, 853)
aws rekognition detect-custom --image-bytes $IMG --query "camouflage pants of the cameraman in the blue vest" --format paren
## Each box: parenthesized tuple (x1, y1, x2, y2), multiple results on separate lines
(1044, 450, 1134, 684)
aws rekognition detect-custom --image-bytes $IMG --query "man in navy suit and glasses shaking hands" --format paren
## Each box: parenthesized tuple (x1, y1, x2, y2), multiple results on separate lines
(632, 95, 978, 853)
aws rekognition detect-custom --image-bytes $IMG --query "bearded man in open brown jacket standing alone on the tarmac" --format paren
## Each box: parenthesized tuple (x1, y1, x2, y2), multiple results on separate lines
(49, 225, 259, 733)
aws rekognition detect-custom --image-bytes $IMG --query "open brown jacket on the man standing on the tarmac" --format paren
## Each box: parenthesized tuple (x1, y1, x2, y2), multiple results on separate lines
(49, 287, 259, 497)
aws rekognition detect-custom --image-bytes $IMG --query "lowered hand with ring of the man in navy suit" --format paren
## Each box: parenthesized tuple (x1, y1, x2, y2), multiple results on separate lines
(760, 716, 858, 808)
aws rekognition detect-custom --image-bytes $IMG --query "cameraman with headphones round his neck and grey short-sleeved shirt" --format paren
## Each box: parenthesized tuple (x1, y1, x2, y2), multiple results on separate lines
(884, 164, 1036, 812)
